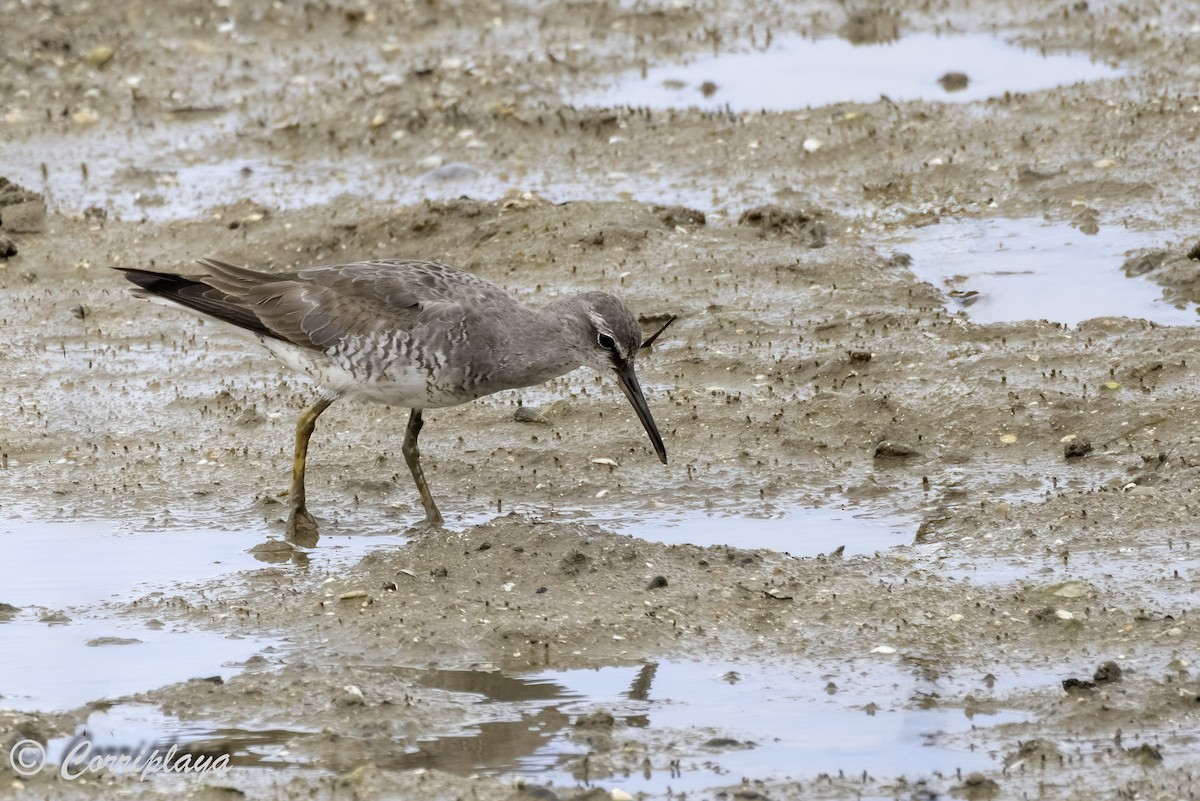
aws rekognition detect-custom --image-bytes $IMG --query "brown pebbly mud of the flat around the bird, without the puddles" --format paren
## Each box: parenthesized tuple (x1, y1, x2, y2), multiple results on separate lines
(0, 0, 1200, 799)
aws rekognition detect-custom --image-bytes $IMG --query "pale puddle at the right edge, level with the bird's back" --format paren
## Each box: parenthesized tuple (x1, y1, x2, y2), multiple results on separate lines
(896, 218, 1196, 325)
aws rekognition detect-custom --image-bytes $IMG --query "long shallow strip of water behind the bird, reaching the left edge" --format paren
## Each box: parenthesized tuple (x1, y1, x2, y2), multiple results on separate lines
(6, 122, 720, 221)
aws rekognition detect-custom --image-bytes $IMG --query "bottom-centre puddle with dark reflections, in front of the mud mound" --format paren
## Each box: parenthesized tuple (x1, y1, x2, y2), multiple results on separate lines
(391, 662, 1024, 793)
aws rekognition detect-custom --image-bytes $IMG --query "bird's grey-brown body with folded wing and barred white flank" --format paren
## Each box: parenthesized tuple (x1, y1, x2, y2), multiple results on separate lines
(222, 260, 542, 408)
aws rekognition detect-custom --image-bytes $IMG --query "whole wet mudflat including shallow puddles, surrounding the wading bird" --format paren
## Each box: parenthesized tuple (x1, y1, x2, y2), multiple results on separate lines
(0, 0, 1200, 800)
